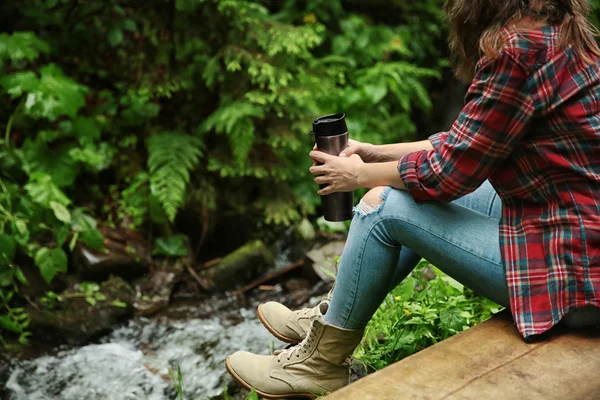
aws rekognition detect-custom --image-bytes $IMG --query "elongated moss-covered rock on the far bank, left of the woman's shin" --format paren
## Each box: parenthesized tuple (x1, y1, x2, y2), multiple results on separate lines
(199, 240, 274, 290)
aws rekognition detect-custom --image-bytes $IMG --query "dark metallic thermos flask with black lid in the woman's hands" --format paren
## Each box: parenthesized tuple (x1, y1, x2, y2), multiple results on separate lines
(310, 113, 354, 222)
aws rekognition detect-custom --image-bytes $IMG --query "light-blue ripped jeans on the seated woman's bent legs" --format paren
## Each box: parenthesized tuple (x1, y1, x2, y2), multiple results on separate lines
(325, 182, 508, 329)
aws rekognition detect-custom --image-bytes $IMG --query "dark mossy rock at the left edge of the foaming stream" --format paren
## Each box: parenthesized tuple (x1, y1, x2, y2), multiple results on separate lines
(27, 277, 135, 343)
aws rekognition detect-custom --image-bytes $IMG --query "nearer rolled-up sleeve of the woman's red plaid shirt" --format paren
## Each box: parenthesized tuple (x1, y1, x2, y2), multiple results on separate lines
(398, 51, 534, 201)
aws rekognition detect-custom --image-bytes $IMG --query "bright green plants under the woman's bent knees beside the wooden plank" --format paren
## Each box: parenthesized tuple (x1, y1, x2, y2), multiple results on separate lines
(355, 260, 502, 369)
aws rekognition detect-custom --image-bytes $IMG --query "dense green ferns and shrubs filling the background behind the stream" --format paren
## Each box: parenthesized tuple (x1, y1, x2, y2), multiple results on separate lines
(0, 0, 496, 342)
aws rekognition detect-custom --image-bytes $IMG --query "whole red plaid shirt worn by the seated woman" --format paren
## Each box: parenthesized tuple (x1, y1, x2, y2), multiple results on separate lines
(398, 26, 600, 338)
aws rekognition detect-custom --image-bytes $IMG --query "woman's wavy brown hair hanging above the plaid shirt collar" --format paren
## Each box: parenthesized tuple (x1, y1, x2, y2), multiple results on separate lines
(445, 0, 600, 82)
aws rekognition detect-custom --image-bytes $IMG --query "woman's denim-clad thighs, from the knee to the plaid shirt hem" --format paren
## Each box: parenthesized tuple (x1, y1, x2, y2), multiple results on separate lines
(379, 183, 509, 306)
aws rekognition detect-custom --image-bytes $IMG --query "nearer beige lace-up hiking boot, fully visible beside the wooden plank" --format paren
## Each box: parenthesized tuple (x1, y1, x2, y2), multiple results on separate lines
(225, 315, 364, 399)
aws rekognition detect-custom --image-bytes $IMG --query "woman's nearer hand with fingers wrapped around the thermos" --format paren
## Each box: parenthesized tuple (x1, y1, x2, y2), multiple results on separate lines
(309, 150, 365, 196)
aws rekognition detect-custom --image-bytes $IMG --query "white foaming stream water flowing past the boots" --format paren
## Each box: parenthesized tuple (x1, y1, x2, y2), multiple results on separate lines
(4, 300, 292, 400)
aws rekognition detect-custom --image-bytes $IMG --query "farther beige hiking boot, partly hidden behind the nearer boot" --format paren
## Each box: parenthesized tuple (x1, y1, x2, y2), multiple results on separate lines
(256, 288, 333, 344)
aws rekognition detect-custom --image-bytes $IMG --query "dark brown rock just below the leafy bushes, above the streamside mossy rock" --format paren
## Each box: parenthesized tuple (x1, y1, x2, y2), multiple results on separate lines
(73, 227, 150, 282)
